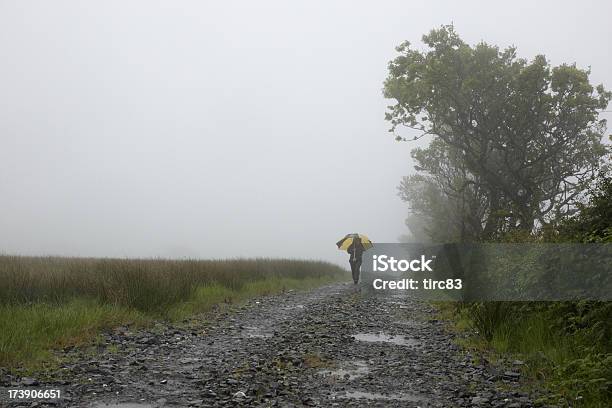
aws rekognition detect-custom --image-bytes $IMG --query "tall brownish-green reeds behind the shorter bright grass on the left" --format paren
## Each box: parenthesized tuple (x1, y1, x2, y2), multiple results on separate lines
(0, 256, 343, 313)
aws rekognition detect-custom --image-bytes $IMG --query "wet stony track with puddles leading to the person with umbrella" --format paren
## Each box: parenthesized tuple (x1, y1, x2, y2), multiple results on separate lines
(0, 284, 532, 408)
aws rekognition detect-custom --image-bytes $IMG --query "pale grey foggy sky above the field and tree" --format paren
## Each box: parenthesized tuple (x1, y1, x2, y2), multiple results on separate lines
(0, 0, 612, 262)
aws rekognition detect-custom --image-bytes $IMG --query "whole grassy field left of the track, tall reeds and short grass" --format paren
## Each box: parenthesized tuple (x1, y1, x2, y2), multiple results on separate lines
(0, 256, 346, 368)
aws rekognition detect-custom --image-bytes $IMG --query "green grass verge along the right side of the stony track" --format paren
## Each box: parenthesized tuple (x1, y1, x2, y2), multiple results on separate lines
(437, 302, 612, 408)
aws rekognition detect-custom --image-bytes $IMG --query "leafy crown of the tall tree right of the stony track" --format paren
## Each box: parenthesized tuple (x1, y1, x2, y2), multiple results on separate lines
(384, 26, 612, 238)
